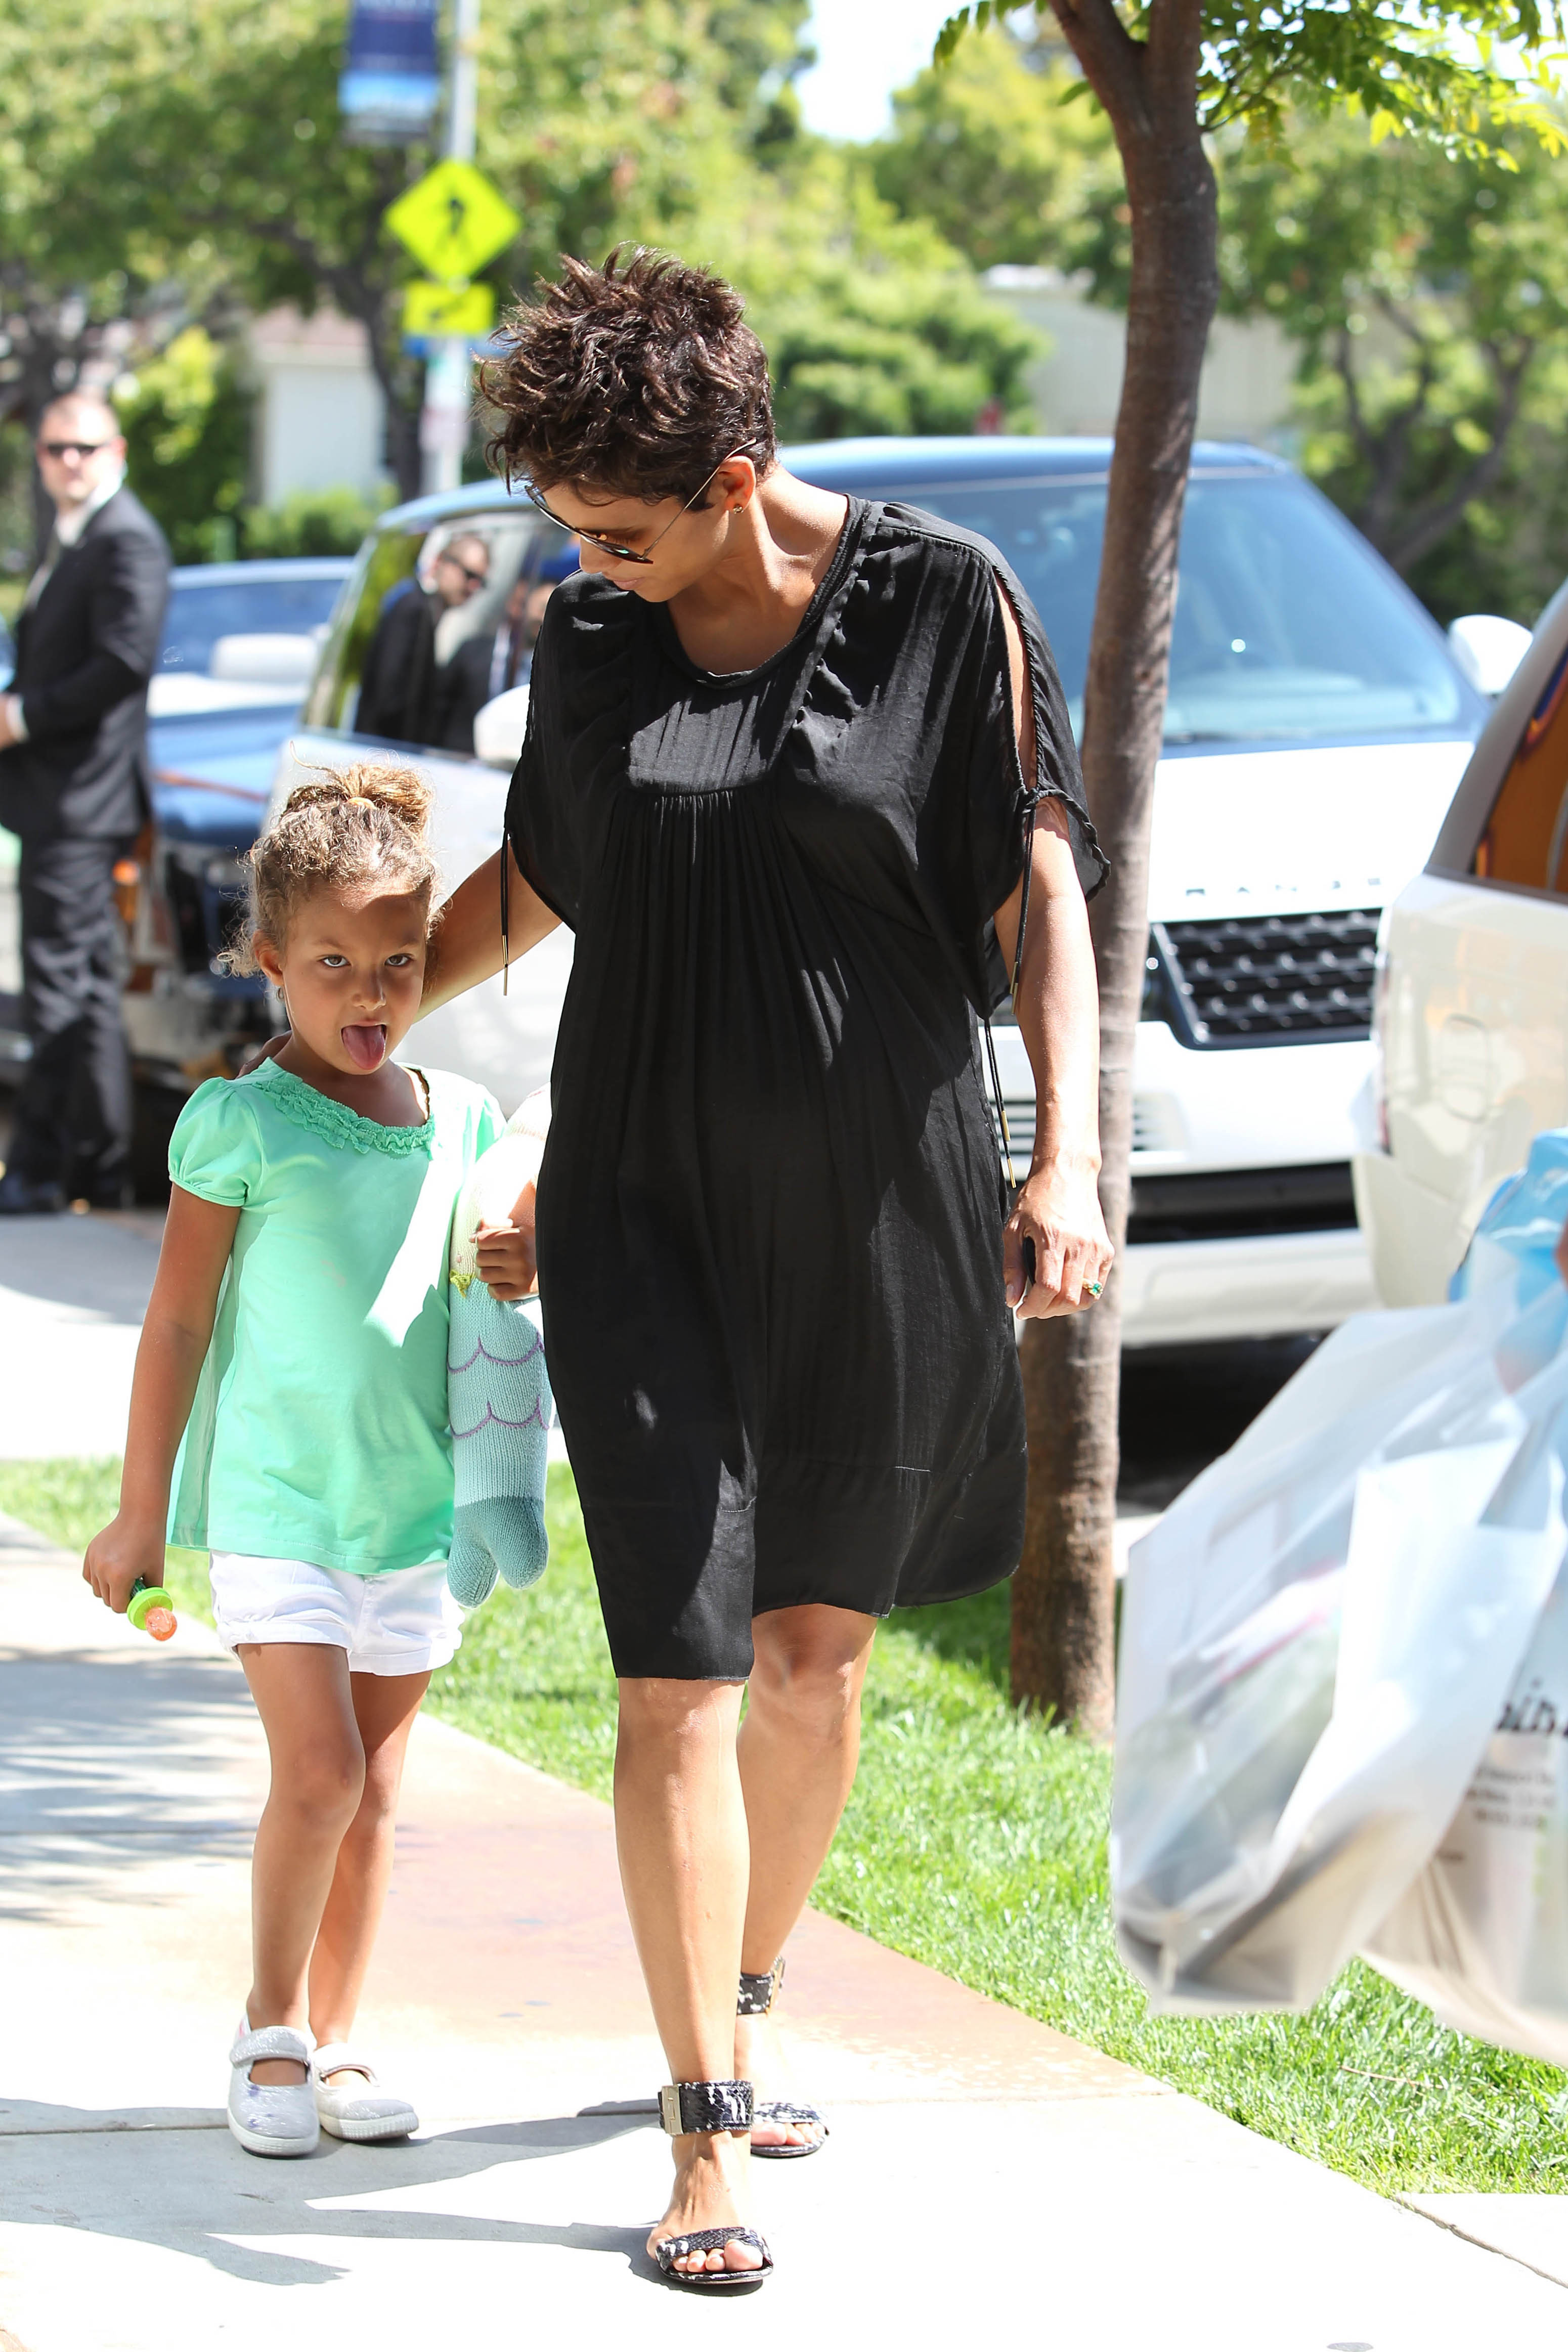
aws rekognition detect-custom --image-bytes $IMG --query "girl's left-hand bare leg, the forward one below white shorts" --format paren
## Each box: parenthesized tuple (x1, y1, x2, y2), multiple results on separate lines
(240, 1642, 364, 2084)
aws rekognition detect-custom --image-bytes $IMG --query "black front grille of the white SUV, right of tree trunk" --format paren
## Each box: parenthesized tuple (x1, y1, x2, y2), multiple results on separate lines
(1145, 908, 1380, 1047)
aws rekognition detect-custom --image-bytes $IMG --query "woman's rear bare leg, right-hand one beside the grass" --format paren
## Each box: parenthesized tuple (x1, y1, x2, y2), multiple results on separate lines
(736, 1604, 877, 2147)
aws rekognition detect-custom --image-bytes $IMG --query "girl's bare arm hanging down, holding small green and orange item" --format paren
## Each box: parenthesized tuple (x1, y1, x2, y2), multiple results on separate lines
(82, 1186, 240, 1614)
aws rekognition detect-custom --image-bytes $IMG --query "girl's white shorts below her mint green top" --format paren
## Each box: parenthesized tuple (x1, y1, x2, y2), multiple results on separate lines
(211, 1552, 463, 1675)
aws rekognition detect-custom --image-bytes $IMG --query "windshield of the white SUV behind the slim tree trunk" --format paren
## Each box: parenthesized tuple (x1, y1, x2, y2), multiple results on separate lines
(891, 475, 1474, 743)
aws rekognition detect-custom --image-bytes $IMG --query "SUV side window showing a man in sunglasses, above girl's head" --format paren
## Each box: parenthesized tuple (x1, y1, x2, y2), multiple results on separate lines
(306, 508, 562, 753)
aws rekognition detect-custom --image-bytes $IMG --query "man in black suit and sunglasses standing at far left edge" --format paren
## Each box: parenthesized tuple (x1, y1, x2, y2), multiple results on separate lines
(0, 393, 169, 1216)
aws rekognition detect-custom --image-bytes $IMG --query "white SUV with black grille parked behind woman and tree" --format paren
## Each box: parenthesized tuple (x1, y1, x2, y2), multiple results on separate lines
(267, 438, 1488, 1345)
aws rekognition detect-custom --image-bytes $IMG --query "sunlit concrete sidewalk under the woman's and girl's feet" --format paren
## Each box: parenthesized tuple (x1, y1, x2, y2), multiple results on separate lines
(0, 1524, 1568, 2352)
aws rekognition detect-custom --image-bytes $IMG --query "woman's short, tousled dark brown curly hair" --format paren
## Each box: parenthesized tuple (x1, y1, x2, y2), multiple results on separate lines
(480, 247, 776, 503)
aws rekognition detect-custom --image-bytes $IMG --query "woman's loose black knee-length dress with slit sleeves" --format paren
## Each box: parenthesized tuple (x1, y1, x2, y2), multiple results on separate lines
(505, 499, 1105, 1679)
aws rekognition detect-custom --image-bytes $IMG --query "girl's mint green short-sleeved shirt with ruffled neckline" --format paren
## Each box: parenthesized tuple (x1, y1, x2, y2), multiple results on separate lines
(169, 1061, 503, 1576)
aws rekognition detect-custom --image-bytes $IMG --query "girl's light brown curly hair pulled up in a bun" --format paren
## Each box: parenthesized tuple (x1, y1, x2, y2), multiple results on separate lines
(221, 760, 435, 974)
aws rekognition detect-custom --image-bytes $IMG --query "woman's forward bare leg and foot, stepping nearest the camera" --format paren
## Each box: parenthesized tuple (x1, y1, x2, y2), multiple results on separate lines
(616, 1677, 762, 2270)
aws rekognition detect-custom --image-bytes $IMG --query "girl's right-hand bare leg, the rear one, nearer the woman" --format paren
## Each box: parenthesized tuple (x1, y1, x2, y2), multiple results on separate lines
(310, 1675, 430, 2044)
